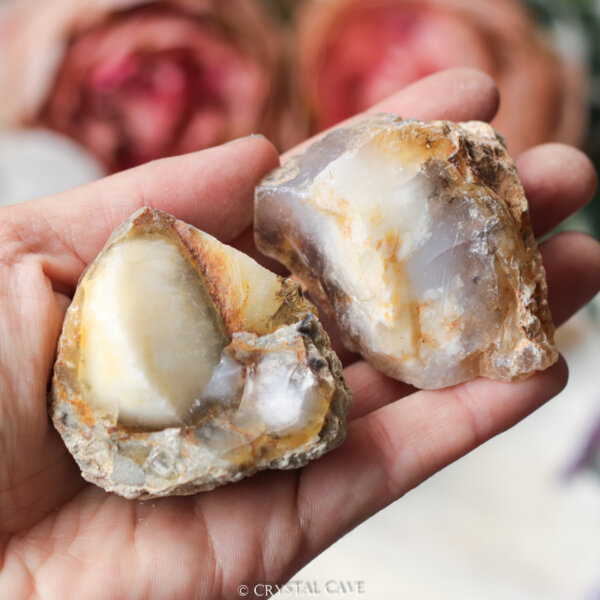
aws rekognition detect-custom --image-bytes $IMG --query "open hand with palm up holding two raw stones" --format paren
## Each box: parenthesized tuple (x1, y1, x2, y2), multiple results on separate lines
(0, 69, 600, 600)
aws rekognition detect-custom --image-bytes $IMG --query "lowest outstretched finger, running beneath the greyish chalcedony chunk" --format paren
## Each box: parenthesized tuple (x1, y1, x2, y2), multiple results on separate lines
(297, 358, 568, 556)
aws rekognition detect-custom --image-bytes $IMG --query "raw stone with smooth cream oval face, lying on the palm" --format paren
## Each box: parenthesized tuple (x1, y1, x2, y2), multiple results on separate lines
(50, 209, 351, 498)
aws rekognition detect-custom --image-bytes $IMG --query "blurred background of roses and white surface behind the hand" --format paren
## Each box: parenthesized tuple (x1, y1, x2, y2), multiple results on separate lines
(0, 0, 600, 600)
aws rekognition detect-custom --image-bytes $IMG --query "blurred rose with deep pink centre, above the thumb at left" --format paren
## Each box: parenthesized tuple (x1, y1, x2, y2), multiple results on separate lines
(0, 0, 279, 171)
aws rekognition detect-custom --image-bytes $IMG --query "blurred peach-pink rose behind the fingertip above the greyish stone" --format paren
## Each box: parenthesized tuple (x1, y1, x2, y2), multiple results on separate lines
(298, 0, 587, 153)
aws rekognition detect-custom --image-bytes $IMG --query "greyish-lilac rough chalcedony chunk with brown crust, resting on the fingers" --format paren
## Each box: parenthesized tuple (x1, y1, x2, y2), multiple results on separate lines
(255, 115, 557, 389)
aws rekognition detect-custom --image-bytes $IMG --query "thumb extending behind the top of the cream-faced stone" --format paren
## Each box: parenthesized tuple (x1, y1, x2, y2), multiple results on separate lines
(2, 136, 279, 290)
